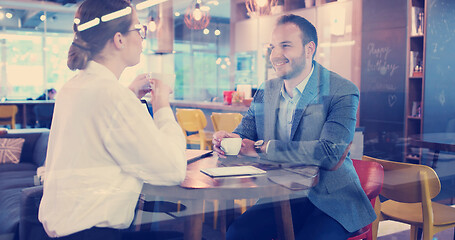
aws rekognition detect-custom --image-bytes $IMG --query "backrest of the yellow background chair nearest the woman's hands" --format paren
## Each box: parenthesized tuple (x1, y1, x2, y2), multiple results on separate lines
(175, 108, 207, 132)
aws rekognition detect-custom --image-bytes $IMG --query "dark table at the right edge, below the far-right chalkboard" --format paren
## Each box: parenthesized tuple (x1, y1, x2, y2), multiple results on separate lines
(411, 133, 455, 168)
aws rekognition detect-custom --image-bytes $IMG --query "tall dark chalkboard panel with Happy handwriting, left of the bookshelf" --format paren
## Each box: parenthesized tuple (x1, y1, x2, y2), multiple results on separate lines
(359, 0, 407, 160)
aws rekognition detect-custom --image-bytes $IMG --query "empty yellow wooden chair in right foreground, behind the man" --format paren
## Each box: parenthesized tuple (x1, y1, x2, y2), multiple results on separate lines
(362, 156, 455, 240)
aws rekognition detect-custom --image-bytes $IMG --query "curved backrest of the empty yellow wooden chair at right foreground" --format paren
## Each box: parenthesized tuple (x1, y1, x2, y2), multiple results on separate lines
(362, 156, 441, 203)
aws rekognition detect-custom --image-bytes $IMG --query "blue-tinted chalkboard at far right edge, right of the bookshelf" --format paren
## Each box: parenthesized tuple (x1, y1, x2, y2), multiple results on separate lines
(423, 0, 455, 133)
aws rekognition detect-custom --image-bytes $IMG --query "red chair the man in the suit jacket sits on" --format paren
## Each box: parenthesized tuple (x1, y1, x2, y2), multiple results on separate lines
(348, 159, 384, 240)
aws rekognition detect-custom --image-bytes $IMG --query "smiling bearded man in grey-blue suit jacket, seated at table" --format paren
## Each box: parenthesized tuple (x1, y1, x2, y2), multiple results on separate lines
(213, 15, 376, 240)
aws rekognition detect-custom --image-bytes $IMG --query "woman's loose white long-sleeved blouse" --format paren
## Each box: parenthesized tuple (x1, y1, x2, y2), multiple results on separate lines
(39, 61, 186, 237)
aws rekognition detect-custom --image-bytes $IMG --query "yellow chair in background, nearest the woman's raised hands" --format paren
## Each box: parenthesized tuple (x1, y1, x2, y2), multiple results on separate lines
(175, 108, 213, 150)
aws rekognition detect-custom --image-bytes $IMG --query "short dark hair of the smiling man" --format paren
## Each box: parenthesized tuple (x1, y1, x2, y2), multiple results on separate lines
(277, 14, 318, 58)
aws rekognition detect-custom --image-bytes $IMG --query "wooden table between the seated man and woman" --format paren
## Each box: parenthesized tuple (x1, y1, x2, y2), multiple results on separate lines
(142, 150, 318, 240)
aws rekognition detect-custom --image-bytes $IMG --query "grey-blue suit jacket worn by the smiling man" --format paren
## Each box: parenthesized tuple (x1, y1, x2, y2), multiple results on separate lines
(234, 62, 376, 232)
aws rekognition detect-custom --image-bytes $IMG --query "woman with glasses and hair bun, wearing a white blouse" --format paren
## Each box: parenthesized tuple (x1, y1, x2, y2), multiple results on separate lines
(39, 0, 186, 239)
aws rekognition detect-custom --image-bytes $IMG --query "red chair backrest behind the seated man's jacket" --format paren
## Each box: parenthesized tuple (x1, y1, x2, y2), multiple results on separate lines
(352, 159, 384, 201)
